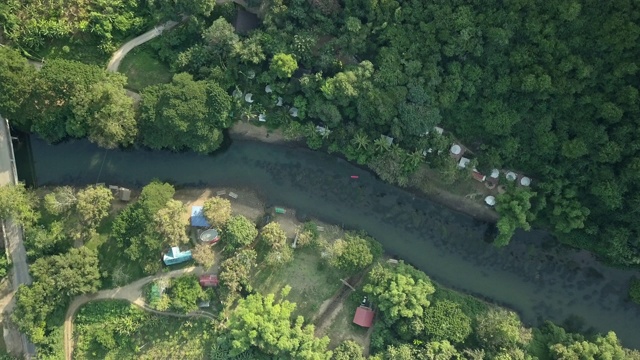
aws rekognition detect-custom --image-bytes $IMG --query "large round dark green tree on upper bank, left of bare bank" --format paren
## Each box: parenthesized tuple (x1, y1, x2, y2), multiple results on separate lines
(140, 73, 231, 153)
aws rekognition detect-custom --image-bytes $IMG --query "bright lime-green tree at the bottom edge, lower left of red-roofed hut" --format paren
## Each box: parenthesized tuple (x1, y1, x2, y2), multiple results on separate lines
(228, 286, 331, 360)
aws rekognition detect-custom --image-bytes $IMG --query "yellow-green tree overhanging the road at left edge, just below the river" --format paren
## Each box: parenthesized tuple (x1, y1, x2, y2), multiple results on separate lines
(0, 183, 38, 225)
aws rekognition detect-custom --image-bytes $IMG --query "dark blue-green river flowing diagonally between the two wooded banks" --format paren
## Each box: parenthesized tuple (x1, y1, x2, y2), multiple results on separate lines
(18, 138, 640, 348)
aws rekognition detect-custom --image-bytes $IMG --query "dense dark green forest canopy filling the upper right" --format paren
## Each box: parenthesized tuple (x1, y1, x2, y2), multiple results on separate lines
(219, 0, 640, 265)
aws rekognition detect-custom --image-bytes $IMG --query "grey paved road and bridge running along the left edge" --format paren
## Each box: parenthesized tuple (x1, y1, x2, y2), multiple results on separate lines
(0, 116, 36, 357)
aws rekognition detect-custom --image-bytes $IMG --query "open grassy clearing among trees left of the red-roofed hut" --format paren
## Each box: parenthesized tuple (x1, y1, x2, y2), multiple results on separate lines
(251, 247, 342, 320)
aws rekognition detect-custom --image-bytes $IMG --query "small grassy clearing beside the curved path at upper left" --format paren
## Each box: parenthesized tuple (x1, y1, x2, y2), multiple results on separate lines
(118, 44, 173, 92)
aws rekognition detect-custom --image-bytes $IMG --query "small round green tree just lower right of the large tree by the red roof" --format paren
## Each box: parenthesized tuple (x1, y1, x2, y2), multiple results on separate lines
(423, 300, 471, 343)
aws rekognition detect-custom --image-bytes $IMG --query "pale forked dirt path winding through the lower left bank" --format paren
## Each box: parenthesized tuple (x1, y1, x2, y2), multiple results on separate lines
(64, 266, 204, 360)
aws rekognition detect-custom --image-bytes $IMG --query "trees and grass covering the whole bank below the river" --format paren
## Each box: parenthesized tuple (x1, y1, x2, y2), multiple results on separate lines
(0, 181, 640, 359)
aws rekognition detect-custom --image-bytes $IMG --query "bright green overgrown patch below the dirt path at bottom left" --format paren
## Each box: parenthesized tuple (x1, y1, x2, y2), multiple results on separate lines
(74, 300, 214, 360)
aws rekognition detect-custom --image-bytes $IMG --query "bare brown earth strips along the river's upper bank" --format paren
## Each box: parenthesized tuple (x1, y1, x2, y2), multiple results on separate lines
(229, 121, 498, 223)
